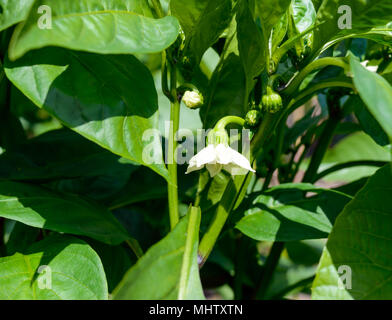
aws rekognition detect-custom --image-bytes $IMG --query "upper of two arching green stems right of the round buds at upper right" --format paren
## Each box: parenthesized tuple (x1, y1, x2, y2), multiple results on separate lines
(282, 57, 349, 96)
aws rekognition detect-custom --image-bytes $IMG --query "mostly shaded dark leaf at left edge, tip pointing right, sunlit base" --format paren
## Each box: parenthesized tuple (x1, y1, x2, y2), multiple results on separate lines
(0, 181, 129, 244)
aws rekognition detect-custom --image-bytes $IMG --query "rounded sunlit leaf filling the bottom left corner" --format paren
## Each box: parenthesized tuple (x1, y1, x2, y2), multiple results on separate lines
(0, 235, 108, 300)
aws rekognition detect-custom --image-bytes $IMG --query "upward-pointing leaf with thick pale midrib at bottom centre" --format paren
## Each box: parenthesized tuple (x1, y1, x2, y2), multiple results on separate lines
(113, 207, 204, 300)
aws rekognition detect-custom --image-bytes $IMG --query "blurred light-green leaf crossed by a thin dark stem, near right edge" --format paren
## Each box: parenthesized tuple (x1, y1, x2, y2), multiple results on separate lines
(319, 132, 391, 182)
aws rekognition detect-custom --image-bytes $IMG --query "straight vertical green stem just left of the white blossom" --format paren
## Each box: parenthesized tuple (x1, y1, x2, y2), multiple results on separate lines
(167, 60, 180, 230)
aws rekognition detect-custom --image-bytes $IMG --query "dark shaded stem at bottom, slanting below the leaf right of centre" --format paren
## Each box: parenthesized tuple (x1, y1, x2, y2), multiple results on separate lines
(256, 241, 284, 300)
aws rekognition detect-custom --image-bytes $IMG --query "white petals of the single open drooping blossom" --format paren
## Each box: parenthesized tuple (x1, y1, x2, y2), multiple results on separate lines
(186, 143, 255, 177)
